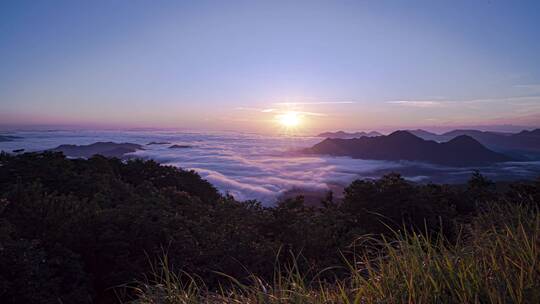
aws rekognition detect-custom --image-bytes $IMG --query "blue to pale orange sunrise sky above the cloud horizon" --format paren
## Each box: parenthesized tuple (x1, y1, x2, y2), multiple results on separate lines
(0, 0, 540, 133)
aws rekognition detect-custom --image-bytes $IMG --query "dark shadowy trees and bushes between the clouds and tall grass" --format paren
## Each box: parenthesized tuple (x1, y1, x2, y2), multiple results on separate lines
(0, 152, 540, 303)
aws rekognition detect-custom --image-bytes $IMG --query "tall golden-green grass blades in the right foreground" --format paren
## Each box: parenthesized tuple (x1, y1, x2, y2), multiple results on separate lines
(130, 204, 540, 304)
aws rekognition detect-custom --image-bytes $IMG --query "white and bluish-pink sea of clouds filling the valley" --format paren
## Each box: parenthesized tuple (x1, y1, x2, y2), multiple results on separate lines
(0, 130, 540, 205)
